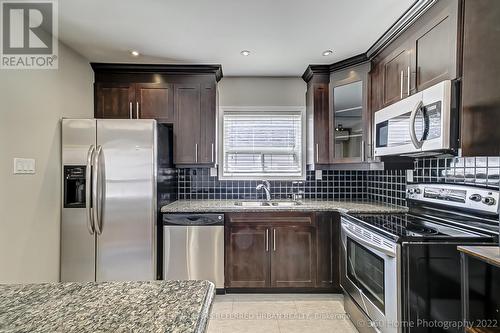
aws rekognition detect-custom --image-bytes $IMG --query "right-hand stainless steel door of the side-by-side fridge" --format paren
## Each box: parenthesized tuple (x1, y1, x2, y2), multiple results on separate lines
(96, 119, 156, 281)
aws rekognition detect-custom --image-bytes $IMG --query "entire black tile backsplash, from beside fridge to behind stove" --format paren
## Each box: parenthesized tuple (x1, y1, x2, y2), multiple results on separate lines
(171, 157, 500, 206)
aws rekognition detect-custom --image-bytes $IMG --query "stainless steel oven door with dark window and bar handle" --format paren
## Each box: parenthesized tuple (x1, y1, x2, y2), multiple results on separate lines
(341, 217, 401, 333)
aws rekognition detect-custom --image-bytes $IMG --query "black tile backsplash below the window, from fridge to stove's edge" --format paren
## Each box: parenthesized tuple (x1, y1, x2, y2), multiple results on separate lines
(178, 168, 406, 205)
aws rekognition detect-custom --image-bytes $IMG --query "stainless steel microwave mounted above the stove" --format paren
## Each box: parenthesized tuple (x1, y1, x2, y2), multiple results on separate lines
(374, 80, 458, 156)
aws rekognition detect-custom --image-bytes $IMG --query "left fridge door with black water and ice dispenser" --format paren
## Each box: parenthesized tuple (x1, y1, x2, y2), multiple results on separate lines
(60, 119, 96, 282)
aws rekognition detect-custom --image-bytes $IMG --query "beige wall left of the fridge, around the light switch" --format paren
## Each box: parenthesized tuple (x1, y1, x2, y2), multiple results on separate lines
(0, 44, 94, 283)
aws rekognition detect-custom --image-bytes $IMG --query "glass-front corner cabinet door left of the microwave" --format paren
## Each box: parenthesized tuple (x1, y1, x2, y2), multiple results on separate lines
(330, 64, 371, 163)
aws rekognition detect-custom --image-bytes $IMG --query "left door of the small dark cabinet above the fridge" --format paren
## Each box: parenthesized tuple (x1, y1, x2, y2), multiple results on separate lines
(94, 83, 135, 119)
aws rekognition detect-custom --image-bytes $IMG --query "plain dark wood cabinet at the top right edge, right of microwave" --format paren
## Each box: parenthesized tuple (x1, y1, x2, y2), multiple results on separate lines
(461, 0, 500, 156)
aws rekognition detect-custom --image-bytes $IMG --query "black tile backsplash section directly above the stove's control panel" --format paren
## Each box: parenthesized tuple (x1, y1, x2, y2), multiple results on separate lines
(414, 157, 500, 188)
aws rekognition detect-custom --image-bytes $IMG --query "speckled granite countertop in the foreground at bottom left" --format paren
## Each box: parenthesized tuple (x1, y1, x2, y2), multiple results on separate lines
(0, 281, 215, 333)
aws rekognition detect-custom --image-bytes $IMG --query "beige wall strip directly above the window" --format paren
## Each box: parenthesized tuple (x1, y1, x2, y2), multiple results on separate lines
(219, 77, 307, 106)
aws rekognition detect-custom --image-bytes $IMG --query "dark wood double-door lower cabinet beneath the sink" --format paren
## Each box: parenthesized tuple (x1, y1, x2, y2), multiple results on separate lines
(225, 212, 340, 291)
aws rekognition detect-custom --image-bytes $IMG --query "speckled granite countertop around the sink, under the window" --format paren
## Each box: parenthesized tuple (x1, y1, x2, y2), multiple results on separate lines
(161, 200, 408, 214)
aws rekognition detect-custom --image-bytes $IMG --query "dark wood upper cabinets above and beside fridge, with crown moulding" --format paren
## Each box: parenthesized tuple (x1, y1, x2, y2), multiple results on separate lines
(91, 63, 222, 166)
